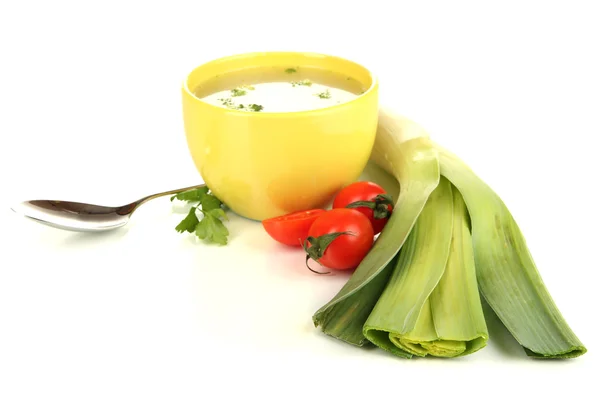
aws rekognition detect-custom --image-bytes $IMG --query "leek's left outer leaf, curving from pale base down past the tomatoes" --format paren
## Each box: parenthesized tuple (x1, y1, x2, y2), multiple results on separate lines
(313, 111, 440, 346)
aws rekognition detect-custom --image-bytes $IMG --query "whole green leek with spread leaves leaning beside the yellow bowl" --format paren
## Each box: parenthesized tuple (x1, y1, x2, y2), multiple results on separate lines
(313, 110, 586, 358)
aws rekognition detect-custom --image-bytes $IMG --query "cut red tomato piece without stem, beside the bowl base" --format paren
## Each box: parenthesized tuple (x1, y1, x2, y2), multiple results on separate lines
(262, 209, 325, 246)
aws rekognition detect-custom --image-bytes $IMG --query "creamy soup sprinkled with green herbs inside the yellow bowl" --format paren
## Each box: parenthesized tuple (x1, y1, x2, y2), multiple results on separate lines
(194, 67, 365, 112)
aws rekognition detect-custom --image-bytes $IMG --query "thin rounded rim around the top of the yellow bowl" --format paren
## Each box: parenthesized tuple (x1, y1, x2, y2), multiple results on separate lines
(182, 51, 379, 118)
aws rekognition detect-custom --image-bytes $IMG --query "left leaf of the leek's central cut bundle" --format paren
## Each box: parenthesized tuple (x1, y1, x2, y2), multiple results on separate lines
(363, 180, 453, 357)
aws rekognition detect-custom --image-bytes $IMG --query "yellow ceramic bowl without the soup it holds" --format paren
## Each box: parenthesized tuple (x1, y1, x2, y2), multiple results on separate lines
(182, 52, 378, 220)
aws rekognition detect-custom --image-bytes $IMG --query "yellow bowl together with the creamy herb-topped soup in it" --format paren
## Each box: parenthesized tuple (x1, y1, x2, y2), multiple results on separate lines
(183, 52, 378, 220)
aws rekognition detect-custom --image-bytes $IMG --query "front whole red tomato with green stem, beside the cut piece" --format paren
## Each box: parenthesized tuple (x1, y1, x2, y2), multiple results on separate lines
(304, 208, 374, 269)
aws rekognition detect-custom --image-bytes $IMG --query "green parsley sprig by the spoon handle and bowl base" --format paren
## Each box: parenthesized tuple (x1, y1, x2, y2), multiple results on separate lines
(171, 186, 229, 245)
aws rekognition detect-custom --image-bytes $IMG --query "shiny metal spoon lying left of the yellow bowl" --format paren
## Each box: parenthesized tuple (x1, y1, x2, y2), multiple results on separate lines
(11, 184, 206, 232)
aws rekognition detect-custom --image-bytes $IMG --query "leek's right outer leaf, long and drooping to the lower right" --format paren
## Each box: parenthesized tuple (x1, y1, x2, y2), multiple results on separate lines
(438, 146, 587, 358)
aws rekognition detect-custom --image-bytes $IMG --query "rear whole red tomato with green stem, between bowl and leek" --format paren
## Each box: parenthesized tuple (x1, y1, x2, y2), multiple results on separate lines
(333, 182, 393, 235)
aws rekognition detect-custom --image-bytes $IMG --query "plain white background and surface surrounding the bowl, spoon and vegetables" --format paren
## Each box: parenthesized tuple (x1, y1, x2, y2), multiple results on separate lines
(0, 0, 600, 400)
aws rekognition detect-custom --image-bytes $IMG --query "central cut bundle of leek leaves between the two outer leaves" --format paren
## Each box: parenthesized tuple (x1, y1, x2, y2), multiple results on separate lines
(364, 178, 488, 358)
